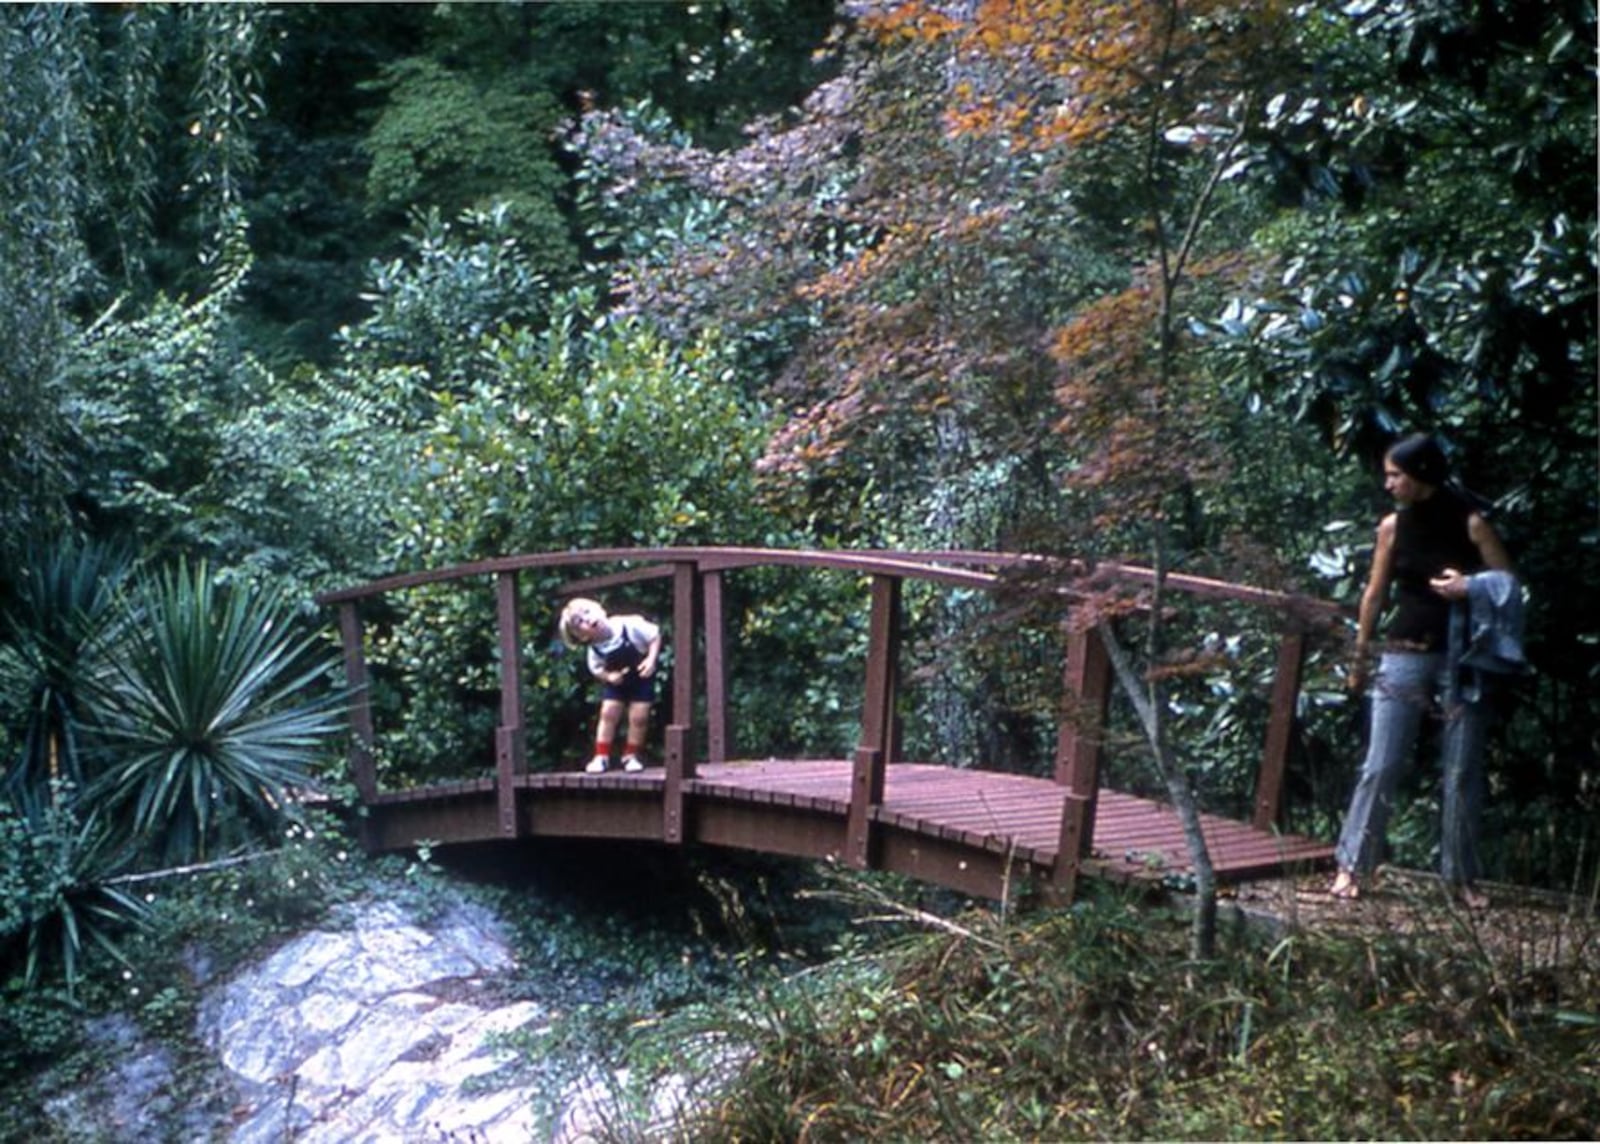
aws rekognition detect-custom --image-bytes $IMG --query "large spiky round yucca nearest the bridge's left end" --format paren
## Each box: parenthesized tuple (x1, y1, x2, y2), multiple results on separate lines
(90, 562, 342, 862)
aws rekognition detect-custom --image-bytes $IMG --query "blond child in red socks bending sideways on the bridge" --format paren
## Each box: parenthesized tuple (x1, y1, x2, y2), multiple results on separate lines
(560, 597, 661, 774)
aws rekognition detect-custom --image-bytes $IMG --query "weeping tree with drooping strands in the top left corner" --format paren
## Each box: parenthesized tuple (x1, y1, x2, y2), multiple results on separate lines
(0, 5, 275, 538)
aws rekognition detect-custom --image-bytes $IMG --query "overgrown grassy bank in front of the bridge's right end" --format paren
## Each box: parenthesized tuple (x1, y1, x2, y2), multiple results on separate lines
(652, 898, 1600, 1141)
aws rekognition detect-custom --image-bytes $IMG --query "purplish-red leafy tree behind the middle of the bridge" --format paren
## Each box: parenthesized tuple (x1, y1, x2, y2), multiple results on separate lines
(581, 31, 1109, 547)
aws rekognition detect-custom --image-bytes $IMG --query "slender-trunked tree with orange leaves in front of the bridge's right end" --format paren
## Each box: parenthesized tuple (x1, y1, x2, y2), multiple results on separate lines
(723, 0, 1288, 955)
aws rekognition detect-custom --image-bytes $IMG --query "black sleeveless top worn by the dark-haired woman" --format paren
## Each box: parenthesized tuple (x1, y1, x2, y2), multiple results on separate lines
(1389, 488, 1483, 651)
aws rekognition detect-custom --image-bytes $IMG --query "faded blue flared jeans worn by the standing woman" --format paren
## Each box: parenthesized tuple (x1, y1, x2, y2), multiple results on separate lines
(1336, 651, 1491, 885)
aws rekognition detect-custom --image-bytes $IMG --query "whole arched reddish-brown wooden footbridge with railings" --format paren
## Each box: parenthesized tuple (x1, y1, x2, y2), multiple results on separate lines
(320, 547, 1331, 898)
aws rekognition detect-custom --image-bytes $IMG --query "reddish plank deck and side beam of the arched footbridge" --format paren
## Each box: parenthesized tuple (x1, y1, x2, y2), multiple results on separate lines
(368, 760, 1333, 898)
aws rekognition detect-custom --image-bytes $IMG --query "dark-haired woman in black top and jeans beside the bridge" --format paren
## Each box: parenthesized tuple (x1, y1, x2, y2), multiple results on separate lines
(1330, 434, 1510, 909)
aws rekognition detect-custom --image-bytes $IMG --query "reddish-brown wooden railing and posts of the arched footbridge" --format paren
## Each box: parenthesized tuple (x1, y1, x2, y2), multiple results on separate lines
(318, 547, 1339, 894)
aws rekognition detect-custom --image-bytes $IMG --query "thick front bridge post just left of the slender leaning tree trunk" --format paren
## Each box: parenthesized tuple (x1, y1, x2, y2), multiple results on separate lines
(1051, 629, 1110, 901)
